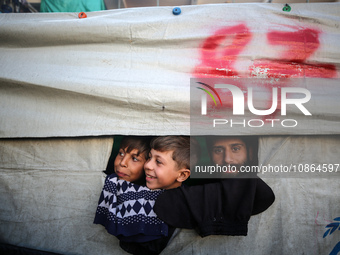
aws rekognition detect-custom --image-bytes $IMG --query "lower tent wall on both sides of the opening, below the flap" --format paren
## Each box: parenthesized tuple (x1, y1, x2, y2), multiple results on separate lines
(0, 136, 340, 255)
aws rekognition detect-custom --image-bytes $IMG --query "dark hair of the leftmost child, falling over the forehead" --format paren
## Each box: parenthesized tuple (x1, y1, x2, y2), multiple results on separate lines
(120, 136, 151, 159)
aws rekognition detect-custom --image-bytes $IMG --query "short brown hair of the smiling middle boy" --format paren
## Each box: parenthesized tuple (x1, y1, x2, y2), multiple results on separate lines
(150, 136, 200, 169)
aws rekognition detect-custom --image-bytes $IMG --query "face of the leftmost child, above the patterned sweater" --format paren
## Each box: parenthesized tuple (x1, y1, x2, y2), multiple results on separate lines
(114, 148, 146, 182)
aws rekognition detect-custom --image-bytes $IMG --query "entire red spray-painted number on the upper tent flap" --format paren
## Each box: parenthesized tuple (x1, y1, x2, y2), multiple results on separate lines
(193, 23, 337, 118)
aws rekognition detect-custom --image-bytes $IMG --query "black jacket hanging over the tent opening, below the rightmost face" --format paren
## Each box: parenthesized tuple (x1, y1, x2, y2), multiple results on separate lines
(154, 178, 275, 237)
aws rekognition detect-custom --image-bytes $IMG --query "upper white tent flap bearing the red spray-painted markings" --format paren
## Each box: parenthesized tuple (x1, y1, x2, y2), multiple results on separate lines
(0, 3, 340, 138)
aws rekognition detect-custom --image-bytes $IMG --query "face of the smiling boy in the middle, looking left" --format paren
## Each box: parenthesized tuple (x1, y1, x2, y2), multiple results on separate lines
(144, 149, 181, 189)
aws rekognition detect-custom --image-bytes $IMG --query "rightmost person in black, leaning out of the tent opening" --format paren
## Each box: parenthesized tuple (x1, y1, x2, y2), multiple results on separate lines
(154, 136, 275, 237)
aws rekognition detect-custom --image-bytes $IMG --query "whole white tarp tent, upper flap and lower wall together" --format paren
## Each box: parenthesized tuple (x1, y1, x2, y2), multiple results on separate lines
(0, 3, 340, 254)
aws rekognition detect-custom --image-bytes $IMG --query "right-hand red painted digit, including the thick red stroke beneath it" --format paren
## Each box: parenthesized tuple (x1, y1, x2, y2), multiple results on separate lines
(249, 27, 337, 78)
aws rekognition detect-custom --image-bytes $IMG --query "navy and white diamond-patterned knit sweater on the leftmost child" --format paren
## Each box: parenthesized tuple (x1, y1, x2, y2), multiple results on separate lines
(94, 174, 168, 242)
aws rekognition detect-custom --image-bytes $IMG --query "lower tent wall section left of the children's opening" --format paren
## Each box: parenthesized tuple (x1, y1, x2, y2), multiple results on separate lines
(0, 138, 114, 254)
